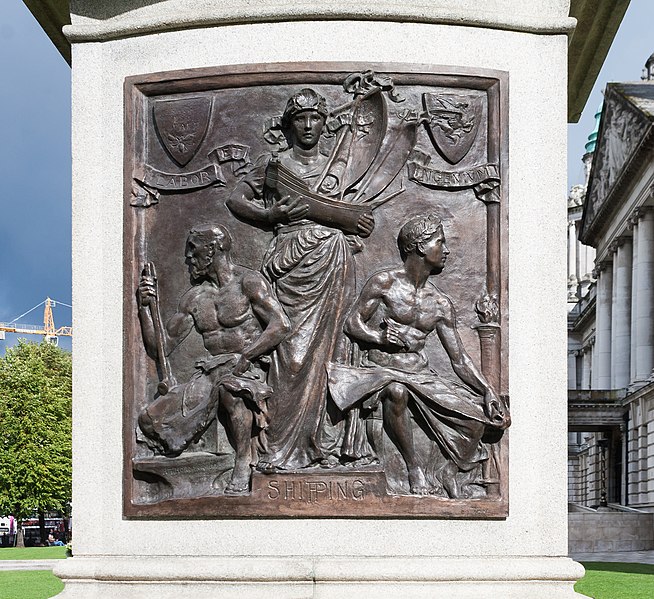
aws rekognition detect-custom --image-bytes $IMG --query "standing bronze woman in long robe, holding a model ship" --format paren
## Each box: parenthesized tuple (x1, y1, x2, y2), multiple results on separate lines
(227, 89, 374, 471)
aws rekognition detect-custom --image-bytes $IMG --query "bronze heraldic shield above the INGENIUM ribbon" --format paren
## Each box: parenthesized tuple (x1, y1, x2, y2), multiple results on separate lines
(422, 93, 483, 164)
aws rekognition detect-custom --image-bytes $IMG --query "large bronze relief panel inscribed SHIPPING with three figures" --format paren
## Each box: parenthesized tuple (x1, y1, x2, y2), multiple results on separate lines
(124, 63, 510, 518)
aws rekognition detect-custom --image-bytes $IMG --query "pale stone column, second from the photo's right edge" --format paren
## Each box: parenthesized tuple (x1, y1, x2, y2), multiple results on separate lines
(611, 237, 632, 389)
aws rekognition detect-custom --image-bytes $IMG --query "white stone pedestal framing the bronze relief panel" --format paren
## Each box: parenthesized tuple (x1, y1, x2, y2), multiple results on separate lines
(55, 0, 596, 599)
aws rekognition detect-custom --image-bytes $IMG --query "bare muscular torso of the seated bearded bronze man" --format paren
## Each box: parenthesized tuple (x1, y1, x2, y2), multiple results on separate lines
(183, 274, 262, 355)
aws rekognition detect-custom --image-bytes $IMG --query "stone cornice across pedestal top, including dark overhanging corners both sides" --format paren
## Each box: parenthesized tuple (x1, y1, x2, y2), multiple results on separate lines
(23, 0, 629, 123)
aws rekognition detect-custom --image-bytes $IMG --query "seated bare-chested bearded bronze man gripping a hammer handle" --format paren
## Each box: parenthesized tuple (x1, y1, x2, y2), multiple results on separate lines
(137, 225, 290, 494)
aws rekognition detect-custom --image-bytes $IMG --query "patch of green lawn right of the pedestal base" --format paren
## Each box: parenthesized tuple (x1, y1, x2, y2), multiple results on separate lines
(575, 562, 654, 599)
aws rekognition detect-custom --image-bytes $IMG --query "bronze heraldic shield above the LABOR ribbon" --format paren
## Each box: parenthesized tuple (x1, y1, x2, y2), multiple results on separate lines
(152, 97, 211, 166)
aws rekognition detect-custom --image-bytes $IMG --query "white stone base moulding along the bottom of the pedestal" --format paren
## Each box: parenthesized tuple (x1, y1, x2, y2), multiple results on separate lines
(55, 556, 583, 599)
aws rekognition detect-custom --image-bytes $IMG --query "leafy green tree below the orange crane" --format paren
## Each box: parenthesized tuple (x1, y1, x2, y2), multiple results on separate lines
(0, 340, 72, 543)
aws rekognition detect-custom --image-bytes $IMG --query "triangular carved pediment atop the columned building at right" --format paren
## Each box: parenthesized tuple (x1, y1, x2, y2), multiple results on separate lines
(579, 82, 654, 246)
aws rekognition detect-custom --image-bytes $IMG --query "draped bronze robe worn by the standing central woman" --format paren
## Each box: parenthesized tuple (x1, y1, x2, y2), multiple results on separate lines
(244, 155, 354, 469)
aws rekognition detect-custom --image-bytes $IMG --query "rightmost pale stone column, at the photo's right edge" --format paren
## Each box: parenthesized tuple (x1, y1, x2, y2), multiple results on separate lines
(634, 210, 654, 384)
